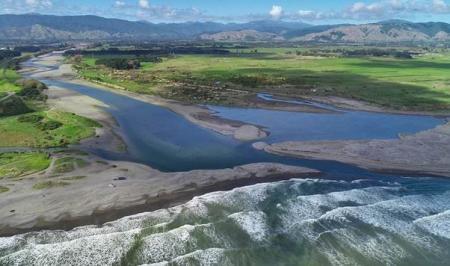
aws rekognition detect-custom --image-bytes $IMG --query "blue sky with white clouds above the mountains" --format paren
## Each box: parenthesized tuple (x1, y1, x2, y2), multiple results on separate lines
(0, 0, 450, 24)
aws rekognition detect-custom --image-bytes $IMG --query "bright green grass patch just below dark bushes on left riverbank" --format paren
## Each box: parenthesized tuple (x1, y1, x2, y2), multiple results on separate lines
(0, 110, 100, 148)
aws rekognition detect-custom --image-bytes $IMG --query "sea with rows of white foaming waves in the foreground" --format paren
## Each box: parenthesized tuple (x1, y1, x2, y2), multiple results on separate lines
(0, 179, 450, 265)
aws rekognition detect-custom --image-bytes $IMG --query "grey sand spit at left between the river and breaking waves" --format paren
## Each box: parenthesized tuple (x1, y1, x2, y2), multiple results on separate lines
(0, 155, 321, 237)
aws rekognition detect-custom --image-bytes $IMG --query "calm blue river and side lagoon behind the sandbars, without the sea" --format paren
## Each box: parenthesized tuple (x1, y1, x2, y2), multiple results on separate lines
(38, 77, 444, 176)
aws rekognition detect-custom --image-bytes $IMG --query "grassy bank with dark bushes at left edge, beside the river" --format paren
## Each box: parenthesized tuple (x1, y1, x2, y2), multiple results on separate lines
(0, 64, 100, 148)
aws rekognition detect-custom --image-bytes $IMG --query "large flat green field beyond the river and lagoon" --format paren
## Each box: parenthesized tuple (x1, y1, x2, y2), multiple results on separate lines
(79, 48, 450, 110)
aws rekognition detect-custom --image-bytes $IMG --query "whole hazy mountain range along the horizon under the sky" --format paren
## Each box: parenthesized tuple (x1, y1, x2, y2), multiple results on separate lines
(0, 14, 450, 43)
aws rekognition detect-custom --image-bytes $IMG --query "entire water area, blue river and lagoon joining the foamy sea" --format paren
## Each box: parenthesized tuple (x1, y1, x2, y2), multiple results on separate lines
(0, 57, 450, 265)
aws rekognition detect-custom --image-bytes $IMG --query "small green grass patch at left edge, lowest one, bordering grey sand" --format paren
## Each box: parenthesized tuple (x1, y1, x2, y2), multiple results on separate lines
(0, 152, 51, 179)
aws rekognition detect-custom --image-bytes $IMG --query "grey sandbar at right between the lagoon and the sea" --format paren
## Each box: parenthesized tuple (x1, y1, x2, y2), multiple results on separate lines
(262, 123, 450, 177)
